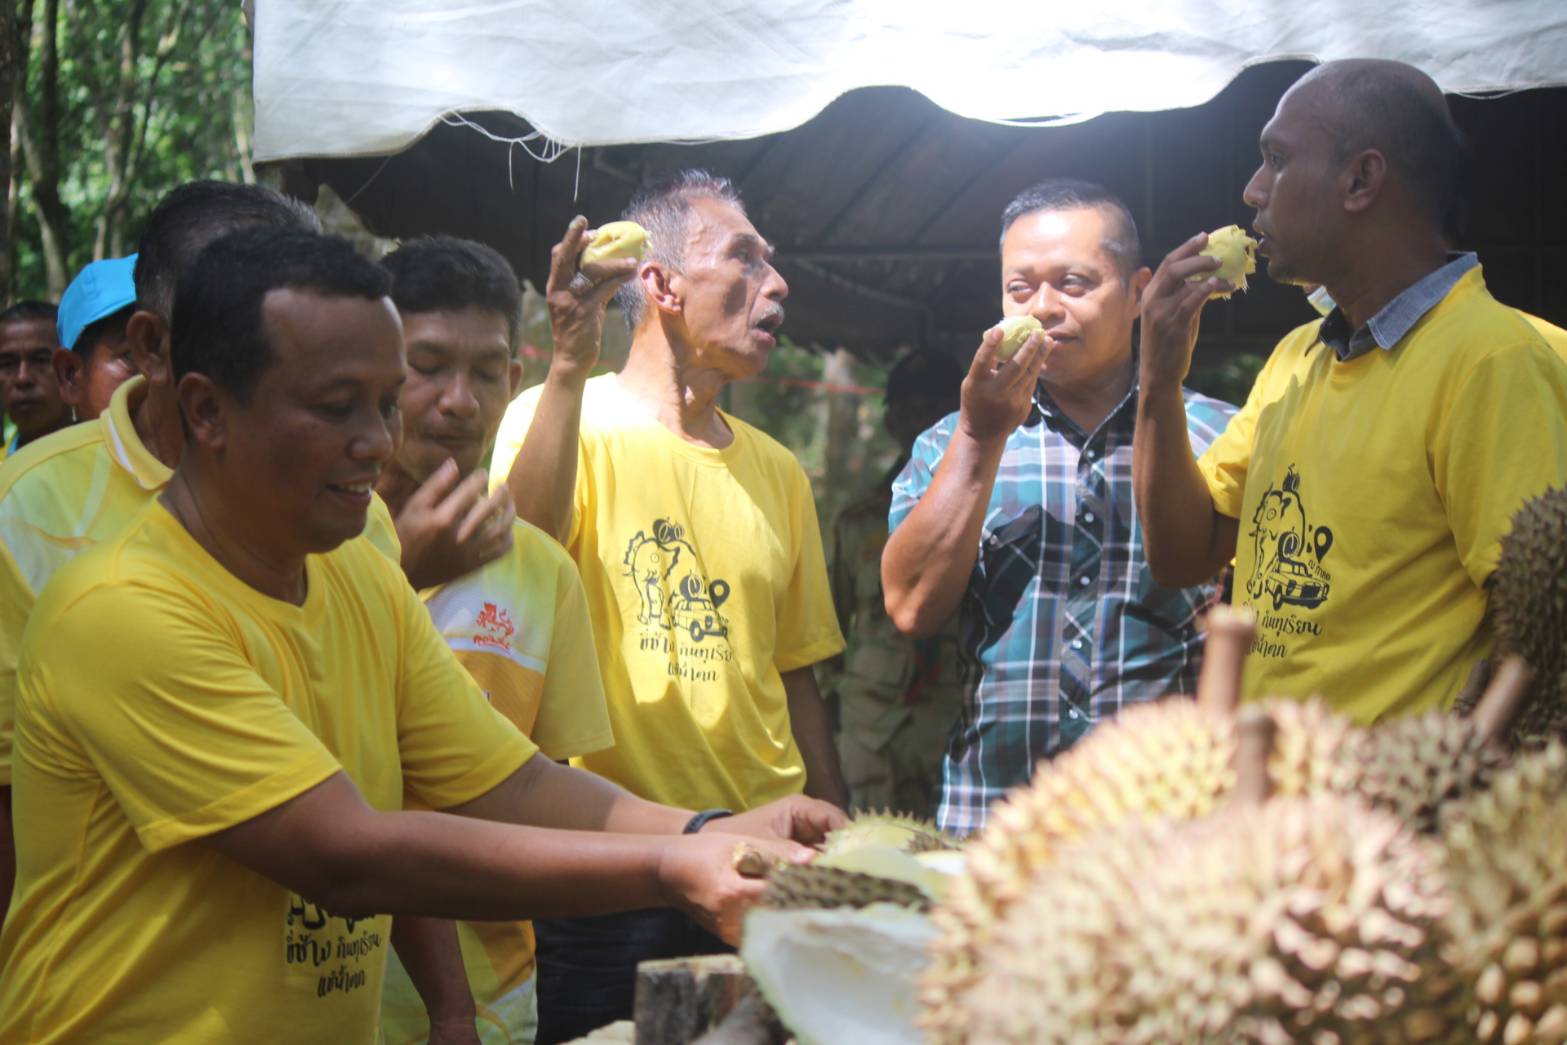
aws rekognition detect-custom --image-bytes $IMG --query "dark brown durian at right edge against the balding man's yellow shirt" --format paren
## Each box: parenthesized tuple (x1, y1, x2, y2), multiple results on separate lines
(1490, 489, 1567, 739)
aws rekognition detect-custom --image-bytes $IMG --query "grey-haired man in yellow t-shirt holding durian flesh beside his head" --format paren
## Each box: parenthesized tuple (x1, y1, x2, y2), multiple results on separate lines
(492, 171, 846, 1042)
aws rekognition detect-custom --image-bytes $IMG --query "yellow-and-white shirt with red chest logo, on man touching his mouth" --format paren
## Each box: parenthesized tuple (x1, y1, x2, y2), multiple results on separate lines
(381, 520, 614, 1045)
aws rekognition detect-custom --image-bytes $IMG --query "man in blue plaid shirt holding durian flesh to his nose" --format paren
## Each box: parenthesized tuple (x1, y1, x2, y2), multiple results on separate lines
(882, 179, 1235, 833)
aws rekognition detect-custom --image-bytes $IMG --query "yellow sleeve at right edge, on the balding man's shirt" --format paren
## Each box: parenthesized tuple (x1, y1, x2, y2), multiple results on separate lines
(1429, 342, 1567, 584)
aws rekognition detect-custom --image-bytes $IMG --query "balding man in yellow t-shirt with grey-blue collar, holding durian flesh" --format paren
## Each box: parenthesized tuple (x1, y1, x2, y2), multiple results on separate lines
(1135, 60, 1567, 722)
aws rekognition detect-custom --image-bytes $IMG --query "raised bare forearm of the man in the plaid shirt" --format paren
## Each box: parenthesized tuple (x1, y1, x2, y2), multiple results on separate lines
(882, 428, 1006, 638)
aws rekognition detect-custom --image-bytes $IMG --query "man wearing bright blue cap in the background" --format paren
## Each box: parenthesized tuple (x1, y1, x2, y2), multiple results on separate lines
(55, 254, 136, 421)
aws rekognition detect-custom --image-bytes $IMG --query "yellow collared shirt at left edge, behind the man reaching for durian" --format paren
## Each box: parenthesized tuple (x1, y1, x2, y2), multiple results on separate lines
(0, 376, 400, 785)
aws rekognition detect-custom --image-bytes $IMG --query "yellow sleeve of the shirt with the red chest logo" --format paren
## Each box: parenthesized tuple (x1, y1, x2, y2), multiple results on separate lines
(533, 559, 614, 761)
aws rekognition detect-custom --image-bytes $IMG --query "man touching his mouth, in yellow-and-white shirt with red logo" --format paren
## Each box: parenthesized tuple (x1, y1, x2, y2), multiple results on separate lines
(376, 237, 614, 1045)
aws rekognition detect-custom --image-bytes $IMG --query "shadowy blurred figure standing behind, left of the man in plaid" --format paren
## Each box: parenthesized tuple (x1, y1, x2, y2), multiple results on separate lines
(831, 353, 964, 816)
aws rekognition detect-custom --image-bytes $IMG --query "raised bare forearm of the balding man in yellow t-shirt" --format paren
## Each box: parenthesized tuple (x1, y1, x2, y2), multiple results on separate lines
(1131, 385, 1235, 588)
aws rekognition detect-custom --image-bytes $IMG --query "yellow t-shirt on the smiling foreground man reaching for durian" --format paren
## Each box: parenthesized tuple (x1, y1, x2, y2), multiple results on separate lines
(0, 503, 536, 1043)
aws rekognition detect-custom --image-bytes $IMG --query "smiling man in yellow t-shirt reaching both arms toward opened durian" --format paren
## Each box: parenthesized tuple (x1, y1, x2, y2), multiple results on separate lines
(0, 229, 841, 1043)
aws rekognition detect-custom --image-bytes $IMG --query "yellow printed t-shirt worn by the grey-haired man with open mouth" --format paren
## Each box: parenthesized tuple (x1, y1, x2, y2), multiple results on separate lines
(490, 374, 843, 810)
